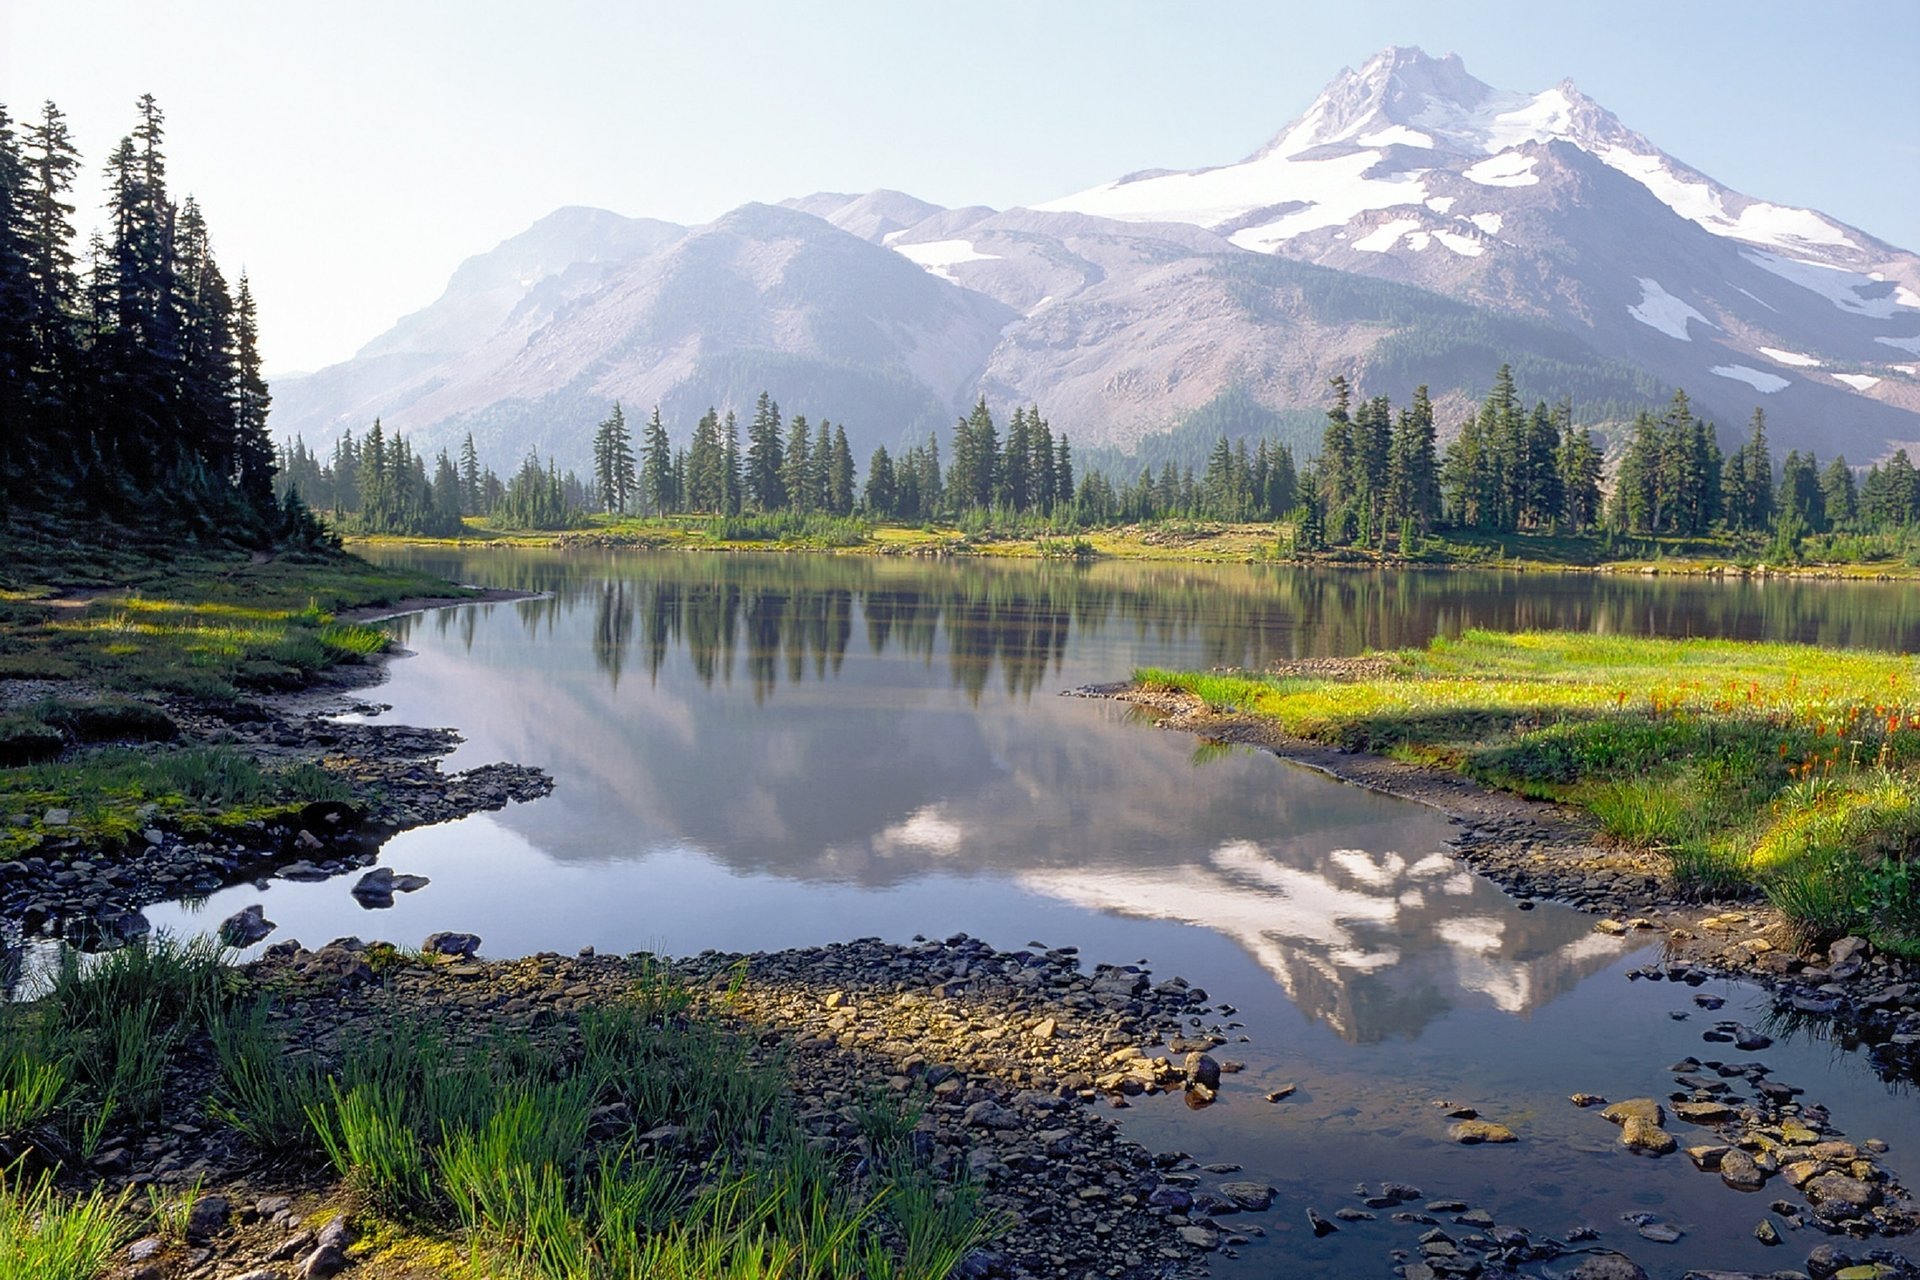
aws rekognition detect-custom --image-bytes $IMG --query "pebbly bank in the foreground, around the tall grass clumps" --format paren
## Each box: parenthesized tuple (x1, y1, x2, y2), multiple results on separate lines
(67, 935, 1251, 1280)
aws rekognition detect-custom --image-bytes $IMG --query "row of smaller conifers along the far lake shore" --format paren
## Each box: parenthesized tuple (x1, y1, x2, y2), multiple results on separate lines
(278, 367, 1920, 553)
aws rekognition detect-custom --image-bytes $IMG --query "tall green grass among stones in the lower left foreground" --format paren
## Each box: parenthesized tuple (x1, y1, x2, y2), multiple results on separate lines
(0, 938, 989, 1280)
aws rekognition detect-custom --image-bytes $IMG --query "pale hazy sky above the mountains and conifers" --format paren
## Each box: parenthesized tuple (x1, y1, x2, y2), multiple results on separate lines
(11, 0, 1920, 374)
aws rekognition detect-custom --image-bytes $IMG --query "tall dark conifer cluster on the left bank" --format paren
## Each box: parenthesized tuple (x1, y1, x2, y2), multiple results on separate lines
(0, 96, 321, 545)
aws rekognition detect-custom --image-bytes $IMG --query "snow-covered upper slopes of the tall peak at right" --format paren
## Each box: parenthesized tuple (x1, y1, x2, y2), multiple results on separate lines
(1039, 48, 1920, 459)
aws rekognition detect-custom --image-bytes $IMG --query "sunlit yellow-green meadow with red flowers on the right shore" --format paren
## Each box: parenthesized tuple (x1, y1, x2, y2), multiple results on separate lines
(1137, 631, 1920, 954)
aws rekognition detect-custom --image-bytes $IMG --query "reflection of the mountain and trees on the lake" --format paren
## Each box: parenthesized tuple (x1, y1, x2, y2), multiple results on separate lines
(318, 551, 1920, 1042)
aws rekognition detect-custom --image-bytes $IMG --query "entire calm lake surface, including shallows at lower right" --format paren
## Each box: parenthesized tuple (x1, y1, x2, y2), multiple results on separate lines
(150, 551, 1920, 1276)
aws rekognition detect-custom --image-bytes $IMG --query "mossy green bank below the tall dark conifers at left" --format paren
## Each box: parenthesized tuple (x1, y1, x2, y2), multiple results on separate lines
(0, 528, 465, 858)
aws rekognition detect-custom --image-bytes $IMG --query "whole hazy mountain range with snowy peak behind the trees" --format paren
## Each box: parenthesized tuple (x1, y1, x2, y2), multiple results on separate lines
(273, 50, 1920, 474)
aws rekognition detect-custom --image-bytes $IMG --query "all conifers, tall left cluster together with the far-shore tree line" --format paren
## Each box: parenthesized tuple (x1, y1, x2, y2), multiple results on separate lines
(11, 96, 1920, 558)
